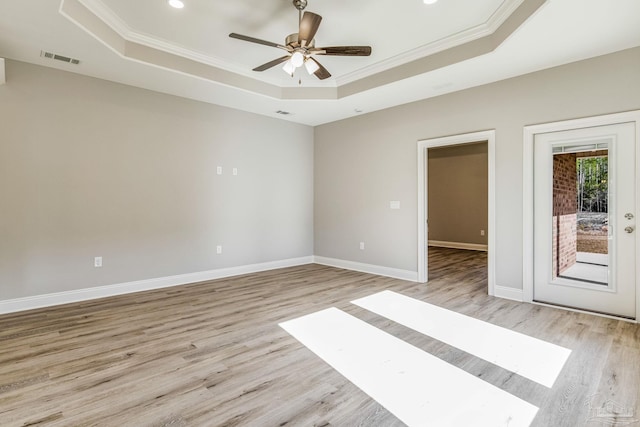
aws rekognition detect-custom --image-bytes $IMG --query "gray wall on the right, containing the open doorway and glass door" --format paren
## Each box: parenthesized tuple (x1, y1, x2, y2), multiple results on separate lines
(314, 48, 640, 288)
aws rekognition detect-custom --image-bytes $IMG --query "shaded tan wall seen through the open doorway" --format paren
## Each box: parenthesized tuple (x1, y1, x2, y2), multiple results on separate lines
(427, 142, 489, 245)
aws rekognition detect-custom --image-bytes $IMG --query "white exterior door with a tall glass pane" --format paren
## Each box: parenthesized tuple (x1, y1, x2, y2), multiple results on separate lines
(533, 123, 636, 318)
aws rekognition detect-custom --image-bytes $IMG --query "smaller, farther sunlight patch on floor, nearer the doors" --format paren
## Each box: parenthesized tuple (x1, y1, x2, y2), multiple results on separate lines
(352, 291, 571, 388)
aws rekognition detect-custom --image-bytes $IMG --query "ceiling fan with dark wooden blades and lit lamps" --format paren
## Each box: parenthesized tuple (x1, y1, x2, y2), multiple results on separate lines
(229, 0, 371, 80)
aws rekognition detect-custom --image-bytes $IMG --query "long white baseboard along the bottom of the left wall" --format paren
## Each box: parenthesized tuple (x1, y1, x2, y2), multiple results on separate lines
(0, 256, 313, 314)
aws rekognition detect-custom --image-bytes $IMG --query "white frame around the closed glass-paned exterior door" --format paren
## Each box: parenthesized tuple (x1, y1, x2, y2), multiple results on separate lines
(522, 110, 640, 322)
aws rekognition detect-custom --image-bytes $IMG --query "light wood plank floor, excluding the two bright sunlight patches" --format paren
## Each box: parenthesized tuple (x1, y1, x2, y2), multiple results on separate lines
(0, 249, 640, 427)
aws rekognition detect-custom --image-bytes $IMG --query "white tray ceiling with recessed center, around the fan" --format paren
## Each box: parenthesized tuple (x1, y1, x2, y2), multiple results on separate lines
(0, 0, 640, 125)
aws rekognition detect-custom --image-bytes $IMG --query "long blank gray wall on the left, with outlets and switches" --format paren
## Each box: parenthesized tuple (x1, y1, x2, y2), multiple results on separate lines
(0, 61, 313, 300)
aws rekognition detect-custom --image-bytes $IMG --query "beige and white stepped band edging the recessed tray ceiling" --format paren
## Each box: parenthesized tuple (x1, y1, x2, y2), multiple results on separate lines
(60, 0, 549, 100)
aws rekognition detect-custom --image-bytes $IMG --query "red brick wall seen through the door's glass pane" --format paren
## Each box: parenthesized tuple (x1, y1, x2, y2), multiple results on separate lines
(553, 153, 578, 277)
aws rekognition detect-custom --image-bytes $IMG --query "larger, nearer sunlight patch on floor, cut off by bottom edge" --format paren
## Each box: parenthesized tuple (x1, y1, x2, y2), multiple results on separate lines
(280, 308, 538, 427)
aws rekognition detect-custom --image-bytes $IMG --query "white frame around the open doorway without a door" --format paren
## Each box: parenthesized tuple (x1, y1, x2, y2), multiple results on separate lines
(418, 129, 496, 295)
